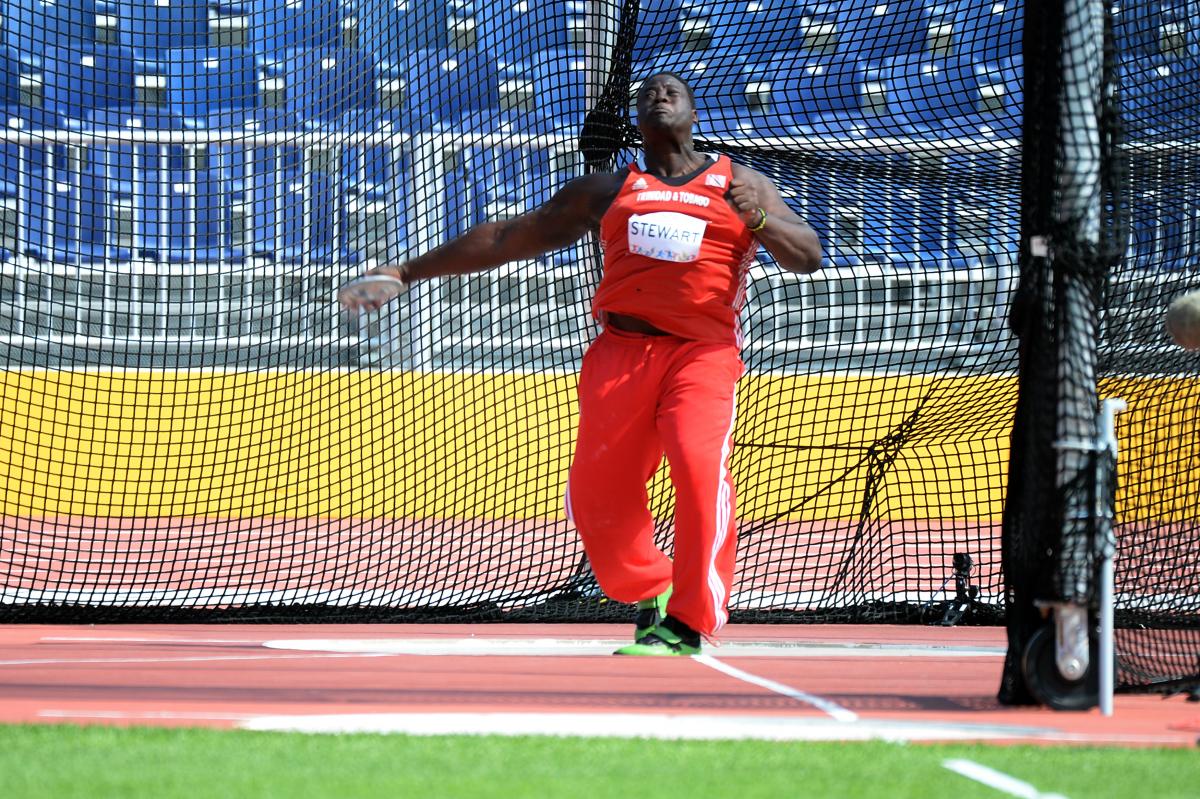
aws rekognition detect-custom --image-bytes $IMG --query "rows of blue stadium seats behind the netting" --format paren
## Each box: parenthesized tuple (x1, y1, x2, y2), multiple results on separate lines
(0, 0, 1032, 268)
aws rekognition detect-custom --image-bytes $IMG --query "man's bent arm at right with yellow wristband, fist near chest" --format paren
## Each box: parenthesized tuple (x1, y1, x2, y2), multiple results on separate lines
(726, 163, 822, 274)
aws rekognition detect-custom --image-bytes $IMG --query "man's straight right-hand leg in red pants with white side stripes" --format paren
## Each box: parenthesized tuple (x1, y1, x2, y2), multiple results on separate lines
(658, 344, 743, 636)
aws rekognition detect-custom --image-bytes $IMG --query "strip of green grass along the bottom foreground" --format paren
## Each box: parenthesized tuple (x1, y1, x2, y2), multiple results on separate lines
(0, 725, 1200, 799)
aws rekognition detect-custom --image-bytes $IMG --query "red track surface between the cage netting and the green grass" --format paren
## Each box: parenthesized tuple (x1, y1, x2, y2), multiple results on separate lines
(0, 625, 1200, 745)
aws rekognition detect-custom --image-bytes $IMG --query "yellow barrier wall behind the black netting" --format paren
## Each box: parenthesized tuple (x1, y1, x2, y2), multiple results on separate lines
(0, 371, 1180, 521)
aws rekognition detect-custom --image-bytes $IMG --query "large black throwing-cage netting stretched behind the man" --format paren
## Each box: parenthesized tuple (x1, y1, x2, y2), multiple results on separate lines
(0, 0, 1198, 686)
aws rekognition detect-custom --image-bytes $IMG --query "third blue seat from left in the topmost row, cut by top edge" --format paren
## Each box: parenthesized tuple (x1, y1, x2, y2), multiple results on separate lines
(250, 0, 348, 62)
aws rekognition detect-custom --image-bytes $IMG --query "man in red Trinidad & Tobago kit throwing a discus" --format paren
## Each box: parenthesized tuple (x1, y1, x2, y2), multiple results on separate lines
(350, 72, 822, 655)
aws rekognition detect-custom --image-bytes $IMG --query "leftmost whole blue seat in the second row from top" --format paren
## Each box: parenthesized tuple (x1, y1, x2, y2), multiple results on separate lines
(44, 46, 134, 119)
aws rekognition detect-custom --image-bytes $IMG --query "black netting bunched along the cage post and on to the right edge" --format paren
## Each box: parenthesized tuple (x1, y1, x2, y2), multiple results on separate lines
(1001, 0, 1200, 703)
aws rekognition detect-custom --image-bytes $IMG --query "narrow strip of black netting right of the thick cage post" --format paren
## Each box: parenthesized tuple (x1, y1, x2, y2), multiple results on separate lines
(1097, 1, 1200, 689)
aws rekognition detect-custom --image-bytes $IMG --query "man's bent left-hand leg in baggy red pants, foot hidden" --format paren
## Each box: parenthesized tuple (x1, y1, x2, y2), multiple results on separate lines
(566, 331, 671, 602)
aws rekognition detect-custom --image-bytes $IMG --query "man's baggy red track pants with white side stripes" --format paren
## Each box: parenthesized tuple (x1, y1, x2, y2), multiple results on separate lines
(566, 329, 743, 636)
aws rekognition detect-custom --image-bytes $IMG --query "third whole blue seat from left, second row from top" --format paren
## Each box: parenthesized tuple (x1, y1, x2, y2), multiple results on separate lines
(279, 48, 376, 126)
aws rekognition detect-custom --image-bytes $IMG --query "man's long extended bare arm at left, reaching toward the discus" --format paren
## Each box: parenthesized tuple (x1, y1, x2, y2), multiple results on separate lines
(370, 173, 624, 283)
